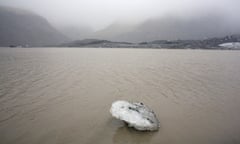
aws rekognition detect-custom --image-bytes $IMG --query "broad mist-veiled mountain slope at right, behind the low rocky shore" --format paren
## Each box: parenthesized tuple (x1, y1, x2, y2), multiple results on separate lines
(92, 14, 240, 42)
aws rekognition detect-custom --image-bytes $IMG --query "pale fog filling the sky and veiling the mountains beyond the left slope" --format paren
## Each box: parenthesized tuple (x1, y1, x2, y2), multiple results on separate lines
(0, 0, 240, 42)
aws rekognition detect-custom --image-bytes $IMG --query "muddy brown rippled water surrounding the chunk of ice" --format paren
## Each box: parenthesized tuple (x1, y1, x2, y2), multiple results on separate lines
(0, 48, 240, 144)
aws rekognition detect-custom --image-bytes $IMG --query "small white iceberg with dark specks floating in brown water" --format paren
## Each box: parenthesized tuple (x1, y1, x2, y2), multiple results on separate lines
(110, 100, 160, 131)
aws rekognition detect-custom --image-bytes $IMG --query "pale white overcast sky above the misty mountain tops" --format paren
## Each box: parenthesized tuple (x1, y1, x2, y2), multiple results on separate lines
(0, 0, 240, 29)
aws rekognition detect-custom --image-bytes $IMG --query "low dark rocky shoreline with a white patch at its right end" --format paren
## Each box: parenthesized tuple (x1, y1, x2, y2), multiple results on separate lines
(2, 35, 240, 50)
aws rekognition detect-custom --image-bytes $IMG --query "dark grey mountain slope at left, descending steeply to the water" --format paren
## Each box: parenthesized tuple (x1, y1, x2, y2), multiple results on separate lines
(0, 6, 68, 46)
